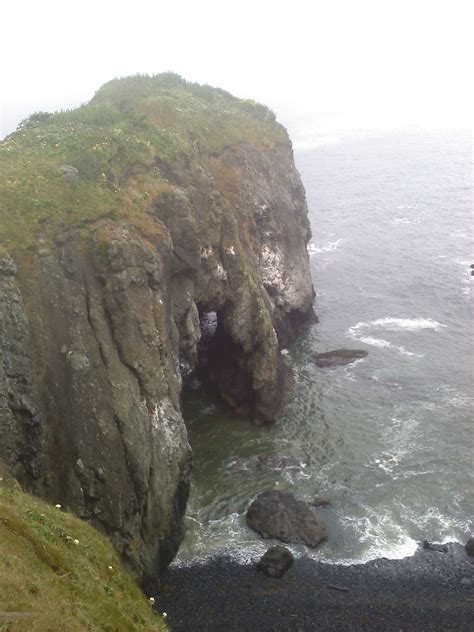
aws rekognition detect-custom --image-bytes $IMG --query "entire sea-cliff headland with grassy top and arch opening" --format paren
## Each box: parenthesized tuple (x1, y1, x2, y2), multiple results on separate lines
(0, 76, 313, 581)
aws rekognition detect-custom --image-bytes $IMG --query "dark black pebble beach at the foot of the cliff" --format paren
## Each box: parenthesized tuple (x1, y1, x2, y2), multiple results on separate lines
(156, 542, 474, 632)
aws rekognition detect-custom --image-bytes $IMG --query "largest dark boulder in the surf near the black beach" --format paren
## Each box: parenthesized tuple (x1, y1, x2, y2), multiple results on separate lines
(246, 490, 327, 548)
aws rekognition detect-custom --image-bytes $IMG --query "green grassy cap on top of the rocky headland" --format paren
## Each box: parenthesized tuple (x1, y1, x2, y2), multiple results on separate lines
(0, 73, 288, 254)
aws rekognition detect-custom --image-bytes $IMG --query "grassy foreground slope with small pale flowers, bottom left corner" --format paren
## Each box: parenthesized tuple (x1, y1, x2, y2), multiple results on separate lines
(0, 480, 168, 632)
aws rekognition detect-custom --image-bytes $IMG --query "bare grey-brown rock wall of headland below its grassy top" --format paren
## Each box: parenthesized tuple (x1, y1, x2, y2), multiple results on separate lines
(0, 118, 313, 582)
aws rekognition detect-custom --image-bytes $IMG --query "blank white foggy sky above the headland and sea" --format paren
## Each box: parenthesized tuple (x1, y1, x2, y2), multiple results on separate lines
(0, 0, 474, 137)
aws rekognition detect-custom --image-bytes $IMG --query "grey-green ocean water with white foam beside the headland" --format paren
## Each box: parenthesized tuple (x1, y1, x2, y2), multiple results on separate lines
(177, 128, 474, 564)
